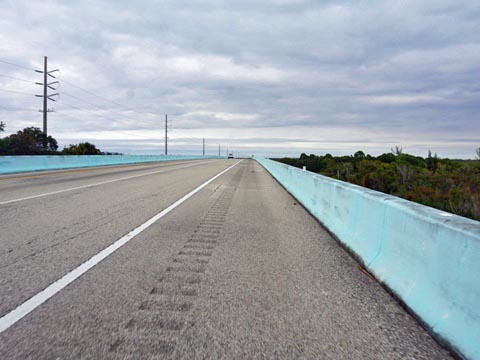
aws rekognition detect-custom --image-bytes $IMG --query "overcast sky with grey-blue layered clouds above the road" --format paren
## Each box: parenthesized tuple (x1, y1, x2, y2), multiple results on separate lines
(0, 0, 480, 158)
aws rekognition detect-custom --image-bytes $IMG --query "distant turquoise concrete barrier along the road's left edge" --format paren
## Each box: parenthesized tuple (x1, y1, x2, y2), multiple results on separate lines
(0, 155, 223, 174)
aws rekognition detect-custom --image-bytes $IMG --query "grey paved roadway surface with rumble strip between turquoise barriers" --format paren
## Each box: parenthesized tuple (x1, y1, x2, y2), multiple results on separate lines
(0, 160, 451, 359)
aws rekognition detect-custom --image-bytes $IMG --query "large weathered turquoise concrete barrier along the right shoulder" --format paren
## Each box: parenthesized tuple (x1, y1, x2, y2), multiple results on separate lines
(257, 159, 480, 359)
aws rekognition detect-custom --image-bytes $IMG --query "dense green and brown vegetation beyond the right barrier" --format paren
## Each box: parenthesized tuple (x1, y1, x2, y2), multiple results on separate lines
(275, 147, 480, 221)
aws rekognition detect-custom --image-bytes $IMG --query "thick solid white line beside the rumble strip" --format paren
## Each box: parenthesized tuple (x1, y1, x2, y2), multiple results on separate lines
(0, 160, 242, 333)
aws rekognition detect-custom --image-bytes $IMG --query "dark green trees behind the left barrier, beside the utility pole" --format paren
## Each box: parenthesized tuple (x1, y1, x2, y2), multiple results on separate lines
(0, 122, 117, 155)
